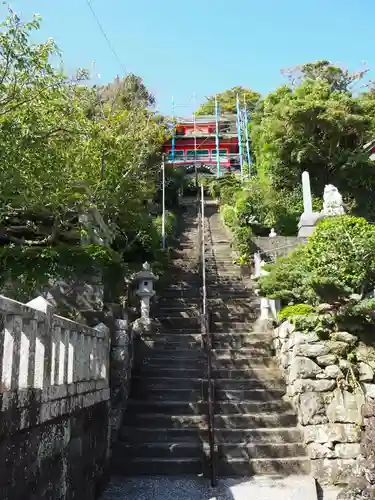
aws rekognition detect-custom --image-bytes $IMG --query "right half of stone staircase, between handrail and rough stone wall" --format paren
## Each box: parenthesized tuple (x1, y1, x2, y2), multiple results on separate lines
(206, 205, 310, 477)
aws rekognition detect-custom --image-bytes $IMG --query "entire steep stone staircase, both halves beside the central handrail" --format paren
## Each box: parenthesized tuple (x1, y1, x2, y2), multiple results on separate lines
(112, 201, 309, 477)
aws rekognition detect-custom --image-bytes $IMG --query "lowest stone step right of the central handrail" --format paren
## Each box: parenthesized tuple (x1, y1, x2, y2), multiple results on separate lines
(217, 456, 311, 477)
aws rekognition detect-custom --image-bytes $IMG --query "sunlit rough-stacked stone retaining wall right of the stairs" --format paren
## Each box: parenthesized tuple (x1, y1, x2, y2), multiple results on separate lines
(274, 322, 375, 484)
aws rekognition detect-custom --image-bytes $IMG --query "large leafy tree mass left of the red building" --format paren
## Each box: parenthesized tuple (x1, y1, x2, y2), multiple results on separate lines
(0, 11, 166, 300)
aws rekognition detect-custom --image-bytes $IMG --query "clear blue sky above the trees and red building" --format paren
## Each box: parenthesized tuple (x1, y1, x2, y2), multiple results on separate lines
(3, 0, 375, 114)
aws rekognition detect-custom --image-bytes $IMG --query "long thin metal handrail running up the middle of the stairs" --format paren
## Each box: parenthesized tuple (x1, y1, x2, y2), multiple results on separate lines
(198, 186, 217, 487)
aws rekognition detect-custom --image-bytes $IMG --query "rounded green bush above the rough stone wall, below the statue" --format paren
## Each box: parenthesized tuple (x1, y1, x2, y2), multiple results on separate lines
(260, 215, 375, 305)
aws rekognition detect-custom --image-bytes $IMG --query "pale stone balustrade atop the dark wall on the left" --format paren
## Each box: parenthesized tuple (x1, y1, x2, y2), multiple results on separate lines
(0, 295, 109, 427)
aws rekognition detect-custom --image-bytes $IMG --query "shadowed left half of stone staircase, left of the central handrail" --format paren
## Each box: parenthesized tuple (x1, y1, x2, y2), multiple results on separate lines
(112, 207, 207, 476)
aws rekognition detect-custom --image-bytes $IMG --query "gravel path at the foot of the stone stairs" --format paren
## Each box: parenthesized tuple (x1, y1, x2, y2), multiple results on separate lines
(101, 476, 317, 500)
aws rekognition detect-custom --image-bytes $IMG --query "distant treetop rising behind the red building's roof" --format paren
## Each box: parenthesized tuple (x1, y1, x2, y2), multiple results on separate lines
(196, 87, 260, 116)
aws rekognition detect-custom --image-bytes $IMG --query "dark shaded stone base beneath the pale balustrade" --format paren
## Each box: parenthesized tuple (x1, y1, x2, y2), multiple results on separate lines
(0, 395, 109, 500)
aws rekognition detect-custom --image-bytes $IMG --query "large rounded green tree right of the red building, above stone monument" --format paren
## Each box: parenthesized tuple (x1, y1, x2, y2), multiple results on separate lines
(251, 79, 375, 214)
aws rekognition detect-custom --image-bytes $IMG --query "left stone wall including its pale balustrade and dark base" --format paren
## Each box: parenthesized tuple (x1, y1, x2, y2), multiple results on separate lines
(0, 297, 110, 500)
